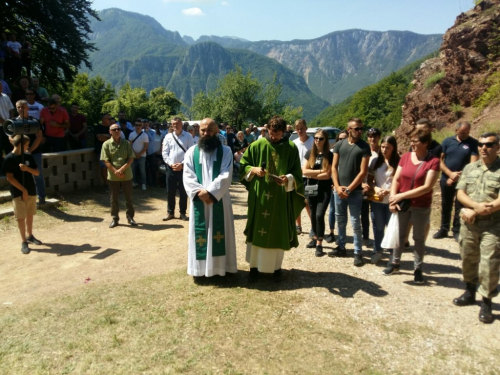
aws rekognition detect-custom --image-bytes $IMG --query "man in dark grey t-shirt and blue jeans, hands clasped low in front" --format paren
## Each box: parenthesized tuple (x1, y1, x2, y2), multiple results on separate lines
(328, 118, 371, 267)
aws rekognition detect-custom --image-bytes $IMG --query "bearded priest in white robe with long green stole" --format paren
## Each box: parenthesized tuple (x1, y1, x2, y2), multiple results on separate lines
(183, 118, 237, 281)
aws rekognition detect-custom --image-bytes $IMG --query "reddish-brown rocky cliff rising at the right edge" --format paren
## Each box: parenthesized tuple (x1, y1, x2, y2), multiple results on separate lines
(396, 0, 500, 139)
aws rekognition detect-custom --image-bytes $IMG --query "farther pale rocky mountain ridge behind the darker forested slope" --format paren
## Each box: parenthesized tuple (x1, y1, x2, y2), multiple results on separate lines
(189, 29, 442, 104)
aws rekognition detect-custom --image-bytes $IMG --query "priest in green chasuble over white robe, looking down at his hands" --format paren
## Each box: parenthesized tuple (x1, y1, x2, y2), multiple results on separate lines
(240, 116, 305, 281)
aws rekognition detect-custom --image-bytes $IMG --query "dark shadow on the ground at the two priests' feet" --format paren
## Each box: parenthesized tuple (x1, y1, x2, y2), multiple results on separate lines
(205, 268, 388, 298)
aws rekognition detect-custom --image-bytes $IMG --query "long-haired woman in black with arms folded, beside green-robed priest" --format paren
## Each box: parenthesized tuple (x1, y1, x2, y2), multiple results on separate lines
(302, 129, 333, 257)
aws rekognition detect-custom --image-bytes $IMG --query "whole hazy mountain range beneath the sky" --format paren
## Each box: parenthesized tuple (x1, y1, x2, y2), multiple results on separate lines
(85, 8, 441, 119)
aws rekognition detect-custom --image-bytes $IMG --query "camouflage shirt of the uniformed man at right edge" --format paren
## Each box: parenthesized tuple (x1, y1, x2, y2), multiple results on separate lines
(457, 158, 500, 219)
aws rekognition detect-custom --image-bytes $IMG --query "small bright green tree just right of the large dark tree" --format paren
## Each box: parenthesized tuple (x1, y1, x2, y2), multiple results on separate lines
(65, 73, 115, 125)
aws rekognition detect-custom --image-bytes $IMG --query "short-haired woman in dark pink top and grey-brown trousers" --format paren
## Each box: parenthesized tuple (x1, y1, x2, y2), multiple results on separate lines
(384, 130, 439, 284)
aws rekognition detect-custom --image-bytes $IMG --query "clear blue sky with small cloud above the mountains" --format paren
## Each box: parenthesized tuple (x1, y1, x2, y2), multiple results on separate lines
(93, 0, 473, 41)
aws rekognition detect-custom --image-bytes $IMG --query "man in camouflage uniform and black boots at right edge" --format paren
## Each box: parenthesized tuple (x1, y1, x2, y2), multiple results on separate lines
(453, 133, 500, 323)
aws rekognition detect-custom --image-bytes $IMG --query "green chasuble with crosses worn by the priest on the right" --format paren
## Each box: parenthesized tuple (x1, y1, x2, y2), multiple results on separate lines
(240, 138, 305, 250)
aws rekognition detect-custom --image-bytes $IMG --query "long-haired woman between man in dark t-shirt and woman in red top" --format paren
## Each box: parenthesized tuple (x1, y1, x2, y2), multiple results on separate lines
(367, 136, 400, 264)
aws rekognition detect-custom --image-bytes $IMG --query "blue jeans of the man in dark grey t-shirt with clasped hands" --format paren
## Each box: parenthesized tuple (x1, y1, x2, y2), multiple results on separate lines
(334, 190, 363, 254)
